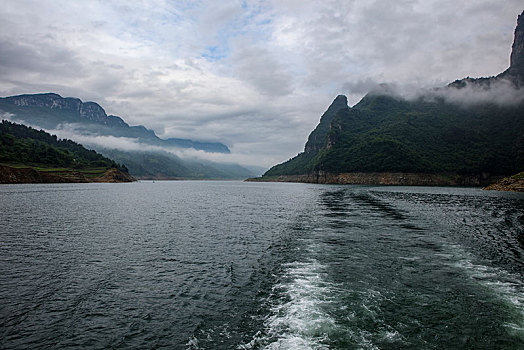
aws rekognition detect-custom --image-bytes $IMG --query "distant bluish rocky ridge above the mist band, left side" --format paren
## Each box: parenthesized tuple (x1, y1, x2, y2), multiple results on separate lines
(0, 93, 230, 153)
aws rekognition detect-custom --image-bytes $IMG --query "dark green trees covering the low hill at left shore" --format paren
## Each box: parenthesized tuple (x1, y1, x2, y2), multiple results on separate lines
(0, 120, 128, 173)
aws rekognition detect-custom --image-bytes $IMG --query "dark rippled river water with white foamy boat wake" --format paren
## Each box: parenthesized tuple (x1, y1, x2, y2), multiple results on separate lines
(0, 182, 524, 349)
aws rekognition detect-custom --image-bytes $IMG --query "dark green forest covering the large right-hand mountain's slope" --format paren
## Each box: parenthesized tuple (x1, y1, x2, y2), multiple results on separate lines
(264, 94, 524, 176)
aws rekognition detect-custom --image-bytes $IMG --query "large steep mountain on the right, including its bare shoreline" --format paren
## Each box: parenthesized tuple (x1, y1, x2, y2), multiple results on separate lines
(262, 13, 524, 185)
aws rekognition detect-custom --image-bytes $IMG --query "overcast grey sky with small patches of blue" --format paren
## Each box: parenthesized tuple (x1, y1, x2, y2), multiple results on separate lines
(0, 0, 524, 166)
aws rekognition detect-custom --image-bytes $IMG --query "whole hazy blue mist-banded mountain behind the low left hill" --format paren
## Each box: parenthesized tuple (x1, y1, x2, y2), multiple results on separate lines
(0, 93, 262, 179)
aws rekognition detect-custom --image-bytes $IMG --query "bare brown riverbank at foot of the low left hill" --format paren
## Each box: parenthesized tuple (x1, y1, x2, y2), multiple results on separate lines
(0, 165, 136, 184)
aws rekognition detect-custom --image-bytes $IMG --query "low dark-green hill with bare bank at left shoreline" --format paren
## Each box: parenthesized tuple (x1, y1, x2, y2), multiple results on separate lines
(0, 120, 134, 183)
